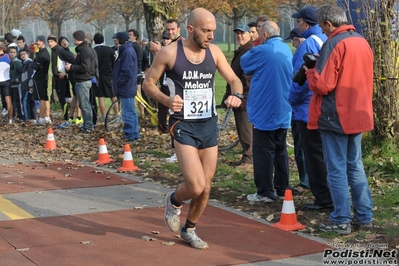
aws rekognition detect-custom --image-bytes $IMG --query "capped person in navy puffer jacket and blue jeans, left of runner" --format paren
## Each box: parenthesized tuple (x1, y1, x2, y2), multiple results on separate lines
(112, 32, 140, 141)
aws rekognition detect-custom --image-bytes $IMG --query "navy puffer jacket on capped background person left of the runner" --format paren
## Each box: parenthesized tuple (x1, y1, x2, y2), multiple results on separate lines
(113, 42, 137, 98)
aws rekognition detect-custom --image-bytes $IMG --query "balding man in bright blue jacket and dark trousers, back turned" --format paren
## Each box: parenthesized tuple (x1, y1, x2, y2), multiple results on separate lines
(240, 21, 292, 202)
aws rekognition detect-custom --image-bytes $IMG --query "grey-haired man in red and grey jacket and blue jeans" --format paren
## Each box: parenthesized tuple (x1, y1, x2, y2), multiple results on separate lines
(305, 5, 374, 234)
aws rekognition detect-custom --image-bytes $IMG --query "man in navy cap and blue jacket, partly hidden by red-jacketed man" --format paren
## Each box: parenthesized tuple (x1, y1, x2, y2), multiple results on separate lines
(289, 6, 332, 210)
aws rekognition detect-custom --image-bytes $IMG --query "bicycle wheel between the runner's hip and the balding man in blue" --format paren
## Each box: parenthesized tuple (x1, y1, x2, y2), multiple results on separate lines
(216, 105, 239, 151)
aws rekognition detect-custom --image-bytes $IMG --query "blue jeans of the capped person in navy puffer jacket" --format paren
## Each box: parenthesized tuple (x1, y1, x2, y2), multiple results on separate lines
(120, 98, 140, 140)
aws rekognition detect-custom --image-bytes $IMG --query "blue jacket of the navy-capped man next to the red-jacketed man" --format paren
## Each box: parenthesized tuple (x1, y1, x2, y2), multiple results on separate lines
(289, 25, 327, 123)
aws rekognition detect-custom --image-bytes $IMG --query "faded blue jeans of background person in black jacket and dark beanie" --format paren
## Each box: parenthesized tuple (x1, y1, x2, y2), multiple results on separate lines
(75, 80, 94, 130)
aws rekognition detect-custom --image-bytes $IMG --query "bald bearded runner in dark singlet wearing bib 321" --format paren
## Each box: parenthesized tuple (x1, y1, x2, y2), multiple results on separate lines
(143, 8, 243, 249)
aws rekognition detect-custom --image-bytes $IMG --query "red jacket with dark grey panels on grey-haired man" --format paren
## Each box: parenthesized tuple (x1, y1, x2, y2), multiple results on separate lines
(306, 25, 374, 134)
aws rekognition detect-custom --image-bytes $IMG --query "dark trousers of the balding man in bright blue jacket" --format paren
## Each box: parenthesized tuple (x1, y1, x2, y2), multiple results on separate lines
(252, 128, 289, 199)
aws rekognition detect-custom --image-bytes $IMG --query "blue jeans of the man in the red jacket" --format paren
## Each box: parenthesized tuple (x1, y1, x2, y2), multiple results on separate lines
(320, 130, 373, 224)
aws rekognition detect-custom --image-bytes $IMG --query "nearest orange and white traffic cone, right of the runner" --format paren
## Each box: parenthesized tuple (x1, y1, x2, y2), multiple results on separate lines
(272, 189, 306, 231)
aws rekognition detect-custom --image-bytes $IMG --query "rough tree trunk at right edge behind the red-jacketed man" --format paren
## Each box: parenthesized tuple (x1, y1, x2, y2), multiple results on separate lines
(353, 0, 399, 143)
